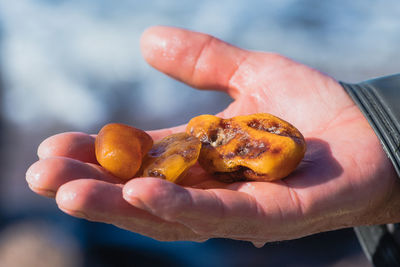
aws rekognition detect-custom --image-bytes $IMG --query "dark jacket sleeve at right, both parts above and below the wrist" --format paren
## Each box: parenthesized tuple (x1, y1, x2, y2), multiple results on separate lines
(341, 74, 400, 266)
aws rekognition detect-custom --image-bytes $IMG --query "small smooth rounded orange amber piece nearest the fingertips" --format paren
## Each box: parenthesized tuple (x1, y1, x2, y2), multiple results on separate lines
(95, 123, 153, 180)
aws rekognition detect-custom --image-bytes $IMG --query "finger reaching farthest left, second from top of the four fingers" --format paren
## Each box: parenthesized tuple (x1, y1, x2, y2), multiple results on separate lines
(26, 157, 123, 197)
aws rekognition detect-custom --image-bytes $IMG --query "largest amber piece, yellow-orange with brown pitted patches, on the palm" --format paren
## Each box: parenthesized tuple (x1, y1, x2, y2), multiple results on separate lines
(186, 113, 306, 182)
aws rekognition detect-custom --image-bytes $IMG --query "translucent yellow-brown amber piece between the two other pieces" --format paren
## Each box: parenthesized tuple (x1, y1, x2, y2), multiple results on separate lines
(142, 133, 201, 183)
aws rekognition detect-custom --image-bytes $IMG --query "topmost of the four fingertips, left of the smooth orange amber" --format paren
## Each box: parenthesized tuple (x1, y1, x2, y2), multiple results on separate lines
(38, 132, 97, 163)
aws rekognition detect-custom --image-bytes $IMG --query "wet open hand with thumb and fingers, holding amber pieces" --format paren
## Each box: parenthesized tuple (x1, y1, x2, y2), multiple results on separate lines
(27, 27, 400, 246)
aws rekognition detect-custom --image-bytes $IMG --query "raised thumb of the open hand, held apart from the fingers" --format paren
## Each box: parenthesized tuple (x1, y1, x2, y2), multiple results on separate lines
(141, 26, 249, 97)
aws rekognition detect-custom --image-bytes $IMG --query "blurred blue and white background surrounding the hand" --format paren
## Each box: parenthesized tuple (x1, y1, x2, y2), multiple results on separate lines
(0, 0, 400, 267)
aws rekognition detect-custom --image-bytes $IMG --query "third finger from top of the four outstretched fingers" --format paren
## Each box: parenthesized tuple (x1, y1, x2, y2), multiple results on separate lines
(56, 179, 205, 241)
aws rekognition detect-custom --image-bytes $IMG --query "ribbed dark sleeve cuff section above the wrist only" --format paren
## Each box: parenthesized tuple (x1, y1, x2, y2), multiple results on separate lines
(341, 74, 400, 177)
